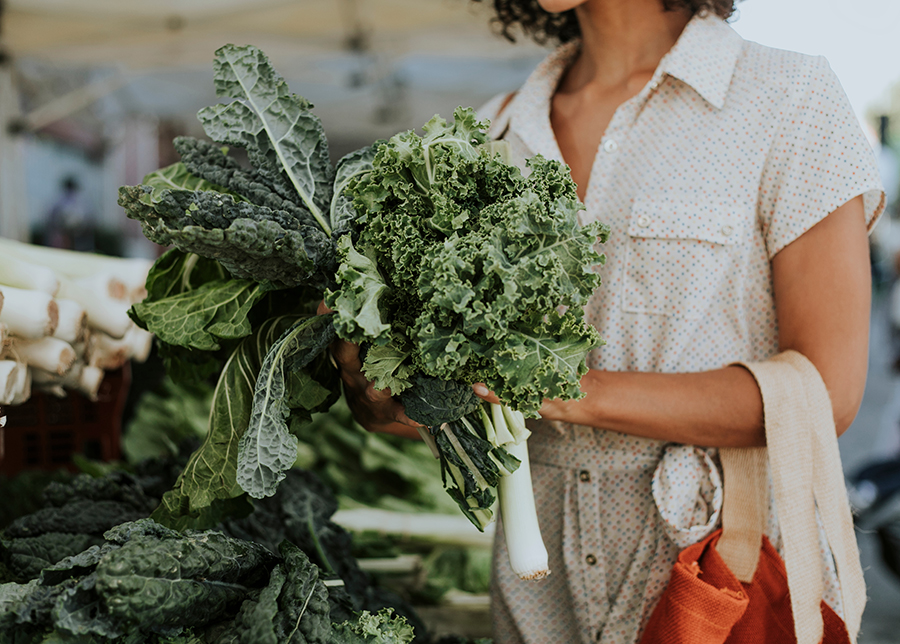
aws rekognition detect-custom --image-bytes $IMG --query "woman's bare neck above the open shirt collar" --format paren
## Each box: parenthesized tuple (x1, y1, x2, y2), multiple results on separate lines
(559, 0, 691, 93)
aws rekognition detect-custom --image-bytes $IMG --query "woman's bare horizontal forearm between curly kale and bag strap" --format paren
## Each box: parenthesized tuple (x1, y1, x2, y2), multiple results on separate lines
(541, 366, 765, 447)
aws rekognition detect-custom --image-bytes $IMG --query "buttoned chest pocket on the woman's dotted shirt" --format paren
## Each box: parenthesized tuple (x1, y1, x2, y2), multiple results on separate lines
(622, 197, 752, 319)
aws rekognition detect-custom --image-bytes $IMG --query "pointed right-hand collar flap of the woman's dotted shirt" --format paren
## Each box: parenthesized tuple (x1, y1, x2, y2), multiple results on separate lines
(657, 15, 744, 109)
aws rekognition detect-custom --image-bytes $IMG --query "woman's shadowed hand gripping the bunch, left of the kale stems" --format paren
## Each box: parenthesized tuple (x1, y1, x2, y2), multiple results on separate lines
(317, 302, 421, 439)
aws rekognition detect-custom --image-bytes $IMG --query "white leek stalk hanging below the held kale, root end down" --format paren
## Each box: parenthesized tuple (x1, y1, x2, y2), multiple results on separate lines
(499, 441, 550, 580)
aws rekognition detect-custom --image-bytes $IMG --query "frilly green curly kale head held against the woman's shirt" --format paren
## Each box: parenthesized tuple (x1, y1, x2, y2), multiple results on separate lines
(327, 109, 609, 415)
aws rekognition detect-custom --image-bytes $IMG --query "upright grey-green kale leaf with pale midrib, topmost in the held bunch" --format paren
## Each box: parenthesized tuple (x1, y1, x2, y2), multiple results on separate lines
(198, 45, 334, 234)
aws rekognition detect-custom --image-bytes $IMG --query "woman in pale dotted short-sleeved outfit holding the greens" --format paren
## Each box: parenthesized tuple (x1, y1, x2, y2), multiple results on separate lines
(326, 0, 883, 644)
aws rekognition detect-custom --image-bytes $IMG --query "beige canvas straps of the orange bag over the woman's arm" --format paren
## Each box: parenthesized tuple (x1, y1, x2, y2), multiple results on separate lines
(717, 351, 866, 644)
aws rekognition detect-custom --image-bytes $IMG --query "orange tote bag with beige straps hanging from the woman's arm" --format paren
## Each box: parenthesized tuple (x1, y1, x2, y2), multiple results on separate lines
(641, 351, 866, 644)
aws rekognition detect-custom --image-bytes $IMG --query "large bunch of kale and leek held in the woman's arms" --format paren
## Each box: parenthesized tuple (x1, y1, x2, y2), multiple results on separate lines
(119, 45, 608, 576)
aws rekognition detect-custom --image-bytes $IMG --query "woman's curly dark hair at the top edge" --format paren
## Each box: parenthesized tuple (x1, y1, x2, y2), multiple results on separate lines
(473, 0, 738, 45)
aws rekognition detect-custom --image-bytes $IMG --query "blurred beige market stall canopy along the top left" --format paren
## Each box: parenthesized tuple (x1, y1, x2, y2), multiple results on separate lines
(3, 0, 536, 70)
